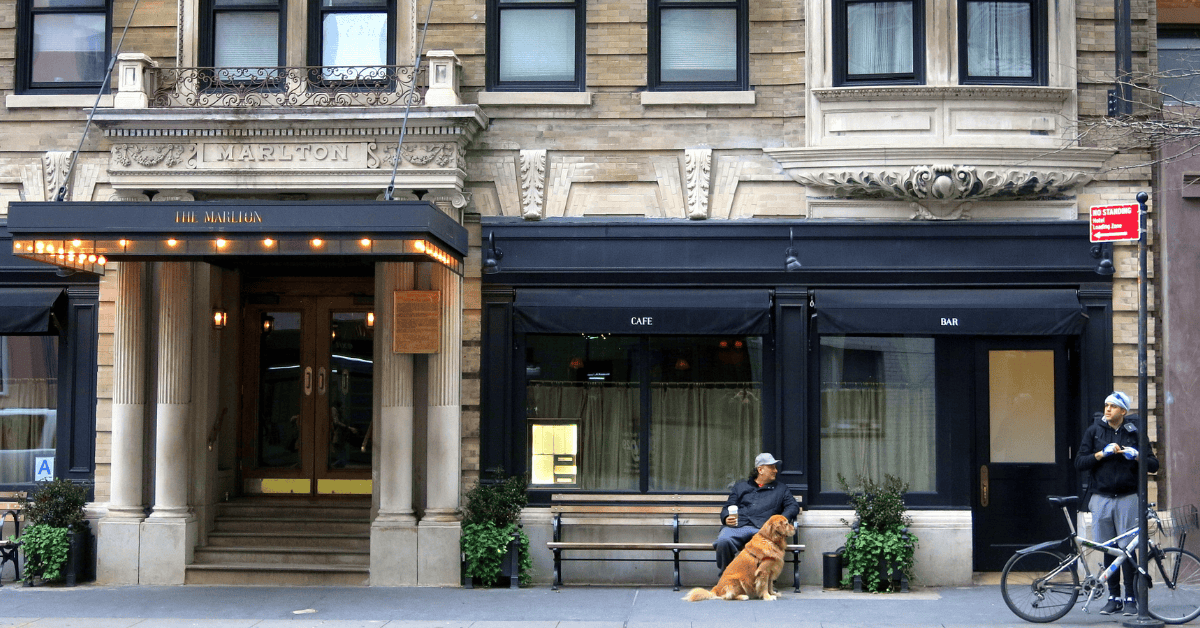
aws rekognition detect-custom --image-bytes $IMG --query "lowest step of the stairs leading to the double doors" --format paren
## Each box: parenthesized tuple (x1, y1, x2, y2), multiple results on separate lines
(184, 563, 371, 586)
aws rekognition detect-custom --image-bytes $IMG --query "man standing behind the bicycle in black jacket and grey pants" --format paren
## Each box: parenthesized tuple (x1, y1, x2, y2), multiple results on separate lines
(1075, 391, 1158, 616)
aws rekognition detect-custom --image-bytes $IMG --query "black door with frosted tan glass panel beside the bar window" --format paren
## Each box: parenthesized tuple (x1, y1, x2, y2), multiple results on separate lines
(972, 339, 1079, 572)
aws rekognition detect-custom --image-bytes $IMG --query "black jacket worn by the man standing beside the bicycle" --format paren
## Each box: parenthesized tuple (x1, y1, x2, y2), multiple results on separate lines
(1075, 414, 1158, 499)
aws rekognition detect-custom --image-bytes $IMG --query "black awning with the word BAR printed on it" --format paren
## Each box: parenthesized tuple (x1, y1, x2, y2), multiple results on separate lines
(814, 288, 1087, 336)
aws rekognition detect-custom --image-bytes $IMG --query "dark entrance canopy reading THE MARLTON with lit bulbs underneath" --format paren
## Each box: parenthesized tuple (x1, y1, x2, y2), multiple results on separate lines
(8, 201, 468, 274)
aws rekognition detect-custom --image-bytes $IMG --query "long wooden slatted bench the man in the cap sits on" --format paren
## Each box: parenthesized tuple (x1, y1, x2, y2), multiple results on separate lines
(546, 492, 804, 592)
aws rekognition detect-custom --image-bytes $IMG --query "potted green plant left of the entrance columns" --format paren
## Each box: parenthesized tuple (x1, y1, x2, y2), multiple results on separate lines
(20, 478, 91, 586)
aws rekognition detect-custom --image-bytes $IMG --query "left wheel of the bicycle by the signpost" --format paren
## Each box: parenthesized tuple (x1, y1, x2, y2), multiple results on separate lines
(1000, 550, 1079, 623)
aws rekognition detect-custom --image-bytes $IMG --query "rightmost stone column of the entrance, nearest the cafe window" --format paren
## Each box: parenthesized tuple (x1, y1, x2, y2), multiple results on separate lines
(418, 264, 462, 585)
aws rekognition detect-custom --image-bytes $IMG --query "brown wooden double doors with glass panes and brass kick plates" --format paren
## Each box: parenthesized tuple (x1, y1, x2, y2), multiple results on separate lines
(241, 297, 374, 495)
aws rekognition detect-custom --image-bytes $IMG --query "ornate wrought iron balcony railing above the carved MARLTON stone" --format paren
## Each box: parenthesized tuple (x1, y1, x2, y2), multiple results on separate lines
(146, 65, 427, 109)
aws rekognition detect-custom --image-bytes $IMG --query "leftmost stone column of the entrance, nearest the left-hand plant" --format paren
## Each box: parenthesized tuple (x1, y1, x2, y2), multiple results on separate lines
(96, 262, 146, 585)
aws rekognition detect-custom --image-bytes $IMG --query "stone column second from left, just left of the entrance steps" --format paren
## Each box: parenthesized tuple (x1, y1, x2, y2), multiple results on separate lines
(142, 262, 194, 585)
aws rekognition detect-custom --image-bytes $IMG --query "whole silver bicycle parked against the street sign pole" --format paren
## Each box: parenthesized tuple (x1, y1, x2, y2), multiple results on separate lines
(1000, 497, 1200, 623)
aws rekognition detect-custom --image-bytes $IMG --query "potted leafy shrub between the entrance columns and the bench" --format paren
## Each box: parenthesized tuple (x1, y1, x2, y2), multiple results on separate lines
(462, 469, 533, 586)
